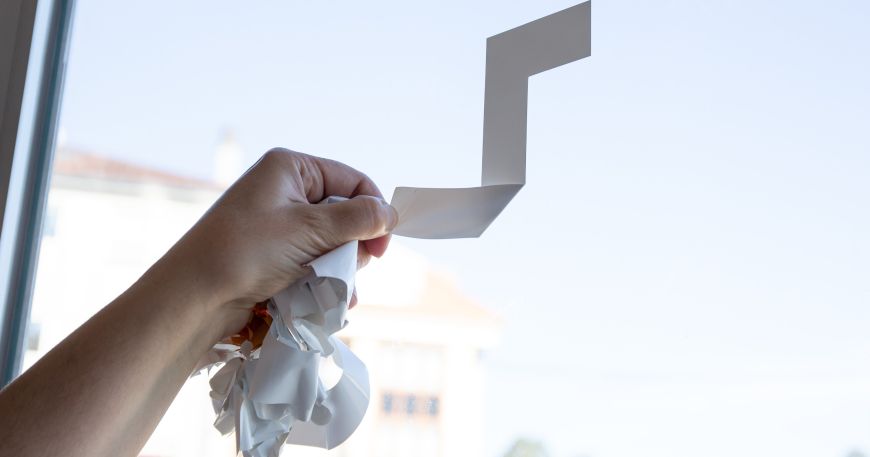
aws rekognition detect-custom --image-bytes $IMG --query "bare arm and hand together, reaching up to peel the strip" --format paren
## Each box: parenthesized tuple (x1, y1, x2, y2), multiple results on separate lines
(0, 149, 398, 457)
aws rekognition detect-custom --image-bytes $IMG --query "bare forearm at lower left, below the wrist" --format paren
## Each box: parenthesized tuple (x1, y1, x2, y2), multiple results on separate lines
(0, 252, 225, 457)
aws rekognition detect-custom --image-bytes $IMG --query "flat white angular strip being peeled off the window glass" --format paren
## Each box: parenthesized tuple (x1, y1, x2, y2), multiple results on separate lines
(391, 2, 592, 238)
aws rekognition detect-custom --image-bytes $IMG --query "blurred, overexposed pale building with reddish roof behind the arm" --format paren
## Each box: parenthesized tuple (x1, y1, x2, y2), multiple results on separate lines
(25, 145, 499, 457)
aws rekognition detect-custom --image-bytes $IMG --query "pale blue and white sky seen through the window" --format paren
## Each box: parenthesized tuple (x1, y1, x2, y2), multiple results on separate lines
(46, 0, 870, 457)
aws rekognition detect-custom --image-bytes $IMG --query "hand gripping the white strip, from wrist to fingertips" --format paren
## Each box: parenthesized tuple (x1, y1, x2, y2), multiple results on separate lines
(161, 149, 398, 336)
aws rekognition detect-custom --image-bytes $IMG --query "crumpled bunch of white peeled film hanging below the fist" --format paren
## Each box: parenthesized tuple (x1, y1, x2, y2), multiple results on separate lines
(203, 241, 369, 457)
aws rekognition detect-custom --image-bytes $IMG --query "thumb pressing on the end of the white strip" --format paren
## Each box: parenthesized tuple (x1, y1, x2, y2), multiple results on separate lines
(311, 195, 399, 244)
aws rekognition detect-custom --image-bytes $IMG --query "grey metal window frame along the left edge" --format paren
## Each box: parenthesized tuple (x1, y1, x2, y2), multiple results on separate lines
(0, 0, 75, 386)
